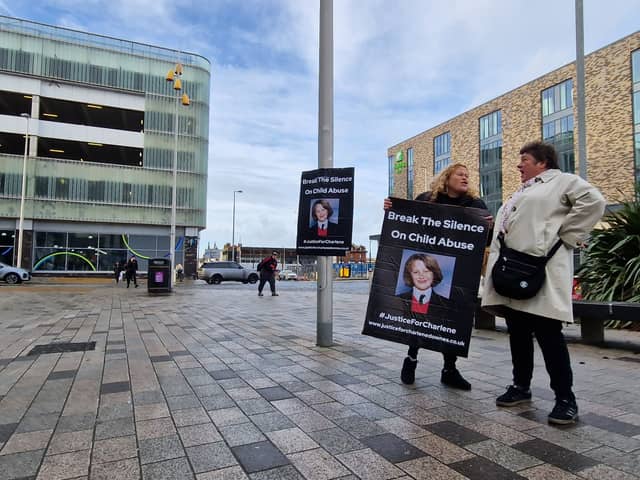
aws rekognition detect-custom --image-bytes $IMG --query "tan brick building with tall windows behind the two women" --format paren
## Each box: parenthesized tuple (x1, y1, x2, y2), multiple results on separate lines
(387, 32, 640, 214)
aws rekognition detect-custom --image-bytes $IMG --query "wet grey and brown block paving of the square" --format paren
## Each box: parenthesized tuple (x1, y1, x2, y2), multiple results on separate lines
(0, 282, 640, 480)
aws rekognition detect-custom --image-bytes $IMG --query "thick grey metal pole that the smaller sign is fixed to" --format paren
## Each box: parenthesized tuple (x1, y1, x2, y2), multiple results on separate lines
(316, 0, 333, 347)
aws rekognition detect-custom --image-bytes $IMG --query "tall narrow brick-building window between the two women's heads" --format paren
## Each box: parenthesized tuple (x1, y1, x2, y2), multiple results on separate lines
(478, 110, 502, 215)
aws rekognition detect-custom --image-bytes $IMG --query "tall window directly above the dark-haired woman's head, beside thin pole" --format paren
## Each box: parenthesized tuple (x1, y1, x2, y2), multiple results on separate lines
(541, 80, 575, 173)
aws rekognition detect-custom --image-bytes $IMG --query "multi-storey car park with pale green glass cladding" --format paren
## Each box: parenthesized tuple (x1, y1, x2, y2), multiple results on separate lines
(0, 17, 210, 275)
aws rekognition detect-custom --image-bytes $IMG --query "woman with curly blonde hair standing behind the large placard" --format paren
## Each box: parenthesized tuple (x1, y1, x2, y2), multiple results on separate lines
(384, 163, 493, 390)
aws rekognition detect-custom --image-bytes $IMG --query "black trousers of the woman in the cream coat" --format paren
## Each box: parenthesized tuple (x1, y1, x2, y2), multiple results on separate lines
(506, 311, 573, 399)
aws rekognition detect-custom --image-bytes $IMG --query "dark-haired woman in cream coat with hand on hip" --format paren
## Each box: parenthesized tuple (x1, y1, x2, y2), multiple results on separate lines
(482, 142, 605, 424)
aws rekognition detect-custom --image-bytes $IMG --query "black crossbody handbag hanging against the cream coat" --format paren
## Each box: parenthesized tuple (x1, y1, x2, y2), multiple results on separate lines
(491, 233, 562, 300)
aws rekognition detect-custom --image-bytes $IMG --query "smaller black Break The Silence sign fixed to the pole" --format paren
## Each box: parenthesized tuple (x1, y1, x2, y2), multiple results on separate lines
(296, 167, 354, 256)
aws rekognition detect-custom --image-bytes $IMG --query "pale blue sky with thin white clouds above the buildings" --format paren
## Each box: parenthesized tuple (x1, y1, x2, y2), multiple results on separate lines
(0, 0, 640, 256)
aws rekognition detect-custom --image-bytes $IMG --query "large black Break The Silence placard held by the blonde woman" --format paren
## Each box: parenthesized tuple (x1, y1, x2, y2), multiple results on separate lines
(362, 198, 489, 357)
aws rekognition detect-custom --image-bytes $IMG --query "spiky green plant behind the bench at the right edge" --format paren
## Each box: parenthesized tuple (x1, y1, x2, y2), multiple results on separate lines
(577, 200, 640, 326)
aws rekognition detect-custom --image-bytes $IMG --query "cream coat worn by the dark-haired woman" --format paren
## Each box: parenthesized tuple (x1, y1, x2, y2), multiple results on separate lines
(482, 169, 606, 322)
